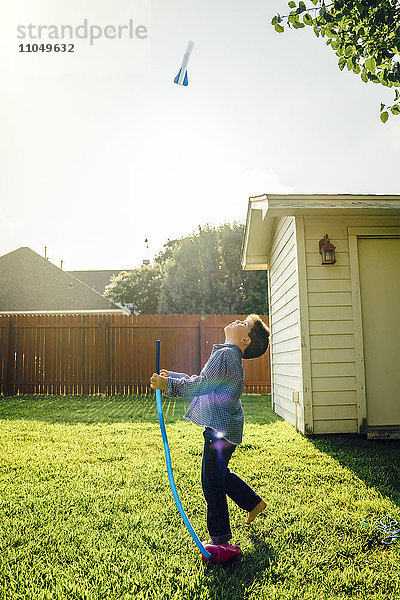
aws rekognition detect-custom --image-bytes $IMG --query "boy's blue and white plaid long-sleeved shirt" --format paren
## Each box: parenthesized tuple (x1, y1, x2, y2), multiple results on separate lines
(166, 344, 244, 444)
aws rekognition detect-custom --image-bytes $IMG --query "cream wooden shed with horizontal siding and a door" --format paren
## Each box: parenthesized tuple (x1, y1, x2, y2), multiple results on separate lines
(242, 194, 400, 437)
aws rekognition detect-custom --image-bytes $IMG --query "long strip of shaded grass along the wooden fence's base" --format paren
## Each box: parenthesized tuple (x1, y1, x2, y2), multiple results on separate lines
(0, 394, 281, 425)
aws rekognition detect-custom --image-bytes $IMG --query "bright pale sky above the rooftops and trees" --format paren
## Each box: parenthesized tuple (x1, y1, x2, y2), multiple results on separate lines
(0, 0, 400, 270)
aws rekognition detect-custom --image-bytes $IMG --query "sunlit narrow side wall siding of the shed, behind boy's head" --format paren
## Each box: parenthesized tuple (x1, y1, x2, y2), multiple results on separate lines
(269, 217, 303, 429)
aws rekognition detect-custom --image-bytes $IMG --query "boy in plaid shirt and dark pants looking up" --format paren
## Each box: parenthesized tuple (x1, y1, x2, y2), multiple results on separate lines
(150, 314, 270, 544)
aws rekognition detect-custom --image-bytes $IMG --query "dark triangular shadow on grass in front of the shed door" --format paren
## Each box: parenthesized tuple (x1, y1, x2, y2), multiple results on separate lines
(308, 435, 400, 506)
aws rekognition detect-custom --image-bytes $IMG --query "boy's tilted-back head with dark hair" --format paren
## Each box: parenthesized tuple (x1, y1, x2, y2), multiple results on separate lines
(225, 314, 270, 358)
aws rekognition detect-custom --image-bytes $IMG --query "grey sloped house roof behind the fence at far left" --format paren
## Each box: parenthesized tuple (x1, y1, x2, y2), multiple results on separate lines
(0, 247, 126, 313)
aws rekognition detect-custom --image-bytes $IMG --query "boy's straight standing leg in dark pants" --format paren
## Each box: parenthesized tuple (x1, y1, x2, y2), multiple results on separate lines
(201, 428, 236, 544)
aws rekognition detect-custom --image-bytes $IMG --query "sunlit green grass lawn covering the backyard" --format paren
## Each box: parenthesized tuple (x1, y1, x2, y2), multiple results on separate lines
(0, 396, 400, 600)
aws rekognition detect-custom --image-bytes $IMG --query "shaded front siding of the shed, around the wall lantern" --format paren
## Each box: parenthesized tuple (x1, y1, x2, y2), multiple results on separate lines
(304, 216, 400, 433)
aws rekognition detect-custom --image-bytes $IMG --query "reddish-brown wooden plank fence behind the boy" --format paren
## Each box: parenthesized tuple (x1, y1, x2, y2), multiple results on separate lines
(0, 314, 271, 395)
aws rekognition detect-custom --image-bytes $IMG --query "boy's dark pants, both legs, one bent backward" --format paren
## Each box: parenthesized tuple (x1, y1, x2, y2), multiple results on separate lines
(201, 427, 261, 544)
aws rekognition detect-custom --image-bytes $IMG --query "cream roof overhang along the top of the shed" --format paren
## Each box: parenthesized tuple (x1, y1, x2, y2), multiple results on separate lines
(242, 194, 400, 270)
